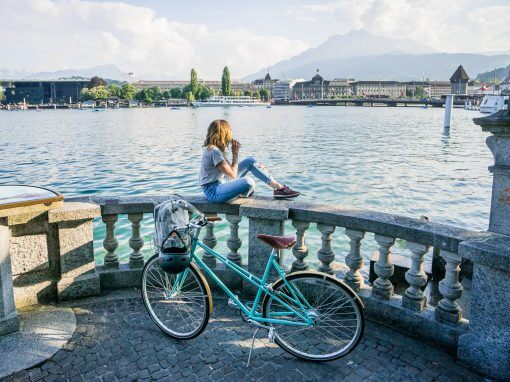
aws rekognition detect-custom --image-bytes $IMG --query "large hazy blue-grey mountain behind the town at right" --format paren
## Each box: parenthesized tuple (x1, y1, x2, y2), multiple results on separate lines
(244, 31, 510, 81)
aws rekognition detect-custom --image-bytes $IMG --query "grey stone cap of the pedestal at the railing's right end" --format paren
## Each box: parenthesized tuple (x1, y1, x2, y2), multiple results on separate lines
(459, 233, 510, 272)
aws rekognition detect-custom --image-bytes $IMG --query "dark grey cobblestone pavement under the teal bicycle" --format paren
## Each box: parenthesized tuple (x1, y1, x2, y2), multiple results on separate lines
(0, 290, 484, 382)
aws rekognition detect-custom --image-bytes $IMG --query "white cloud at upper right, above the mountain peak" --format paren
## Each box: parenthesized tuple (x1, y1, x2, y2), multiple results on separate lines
(293, 0, 510, 53)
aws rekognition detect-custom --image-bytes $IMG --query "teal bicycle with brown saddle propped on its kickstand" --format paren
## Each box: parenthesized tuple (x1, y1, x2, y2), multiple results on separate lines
(142, 200, 365, 362)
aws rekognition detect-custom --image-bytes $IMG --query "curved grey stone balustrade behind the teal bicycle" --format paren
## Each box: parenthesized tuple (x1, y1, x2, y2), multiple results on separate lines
(66, 196, 490, 349)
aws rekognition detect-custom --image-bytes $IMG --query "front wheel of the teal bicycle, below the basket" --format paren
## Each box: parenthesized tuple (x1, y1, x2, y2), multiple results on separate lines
(142, 255, 212, 339)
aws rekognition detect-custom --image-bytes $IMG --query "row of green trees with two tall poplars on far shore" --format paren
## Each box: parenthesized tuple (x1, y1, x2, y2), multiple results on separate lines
(80, 66, 269, 103)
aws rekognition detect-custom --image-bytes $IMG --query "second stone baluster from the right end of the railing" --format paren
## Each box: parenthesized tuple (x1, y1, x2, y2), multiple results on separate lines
(402, 241, 430, 312)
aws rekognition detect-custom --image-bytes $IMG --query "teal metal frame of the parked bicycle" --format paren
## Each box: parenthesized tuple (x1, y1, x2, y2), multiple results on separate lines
(175, 225, 313, 326)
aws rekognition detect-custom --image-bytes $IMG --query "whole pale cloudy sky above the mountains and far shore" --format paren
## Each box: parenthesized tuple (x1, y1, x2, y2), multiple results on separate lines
(0, 0, 510, 79)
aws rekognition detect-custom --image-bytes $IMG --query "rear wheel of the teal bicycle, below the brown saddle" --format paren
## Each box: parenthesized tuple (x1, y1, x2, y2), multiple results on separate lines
(262, 272, 365, 362)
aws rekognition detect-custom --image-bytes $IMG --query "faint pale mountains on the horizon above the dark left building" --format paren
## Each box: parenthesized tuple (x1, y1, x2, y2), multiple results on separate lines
(0, 65, 128, 81)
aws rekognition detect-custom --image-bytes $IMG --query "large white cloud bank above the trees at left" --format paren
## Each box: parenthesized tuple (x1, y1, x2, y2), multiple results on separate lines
(0, 0, 308, 79)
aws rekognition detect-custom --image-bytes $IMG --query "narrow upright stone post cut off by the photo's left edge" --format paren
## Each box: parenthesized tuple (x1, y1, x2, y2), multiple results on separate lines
(0, 218, 20, 336)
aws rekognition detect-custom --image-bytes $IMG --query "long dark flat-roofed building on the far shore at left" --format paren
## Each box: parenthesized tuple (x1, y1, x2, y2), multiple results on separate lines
(2, 80, 89, 104)
